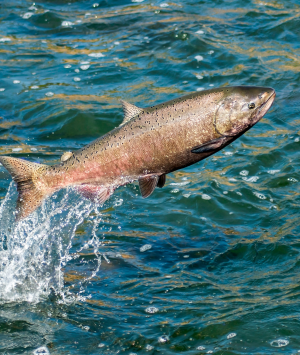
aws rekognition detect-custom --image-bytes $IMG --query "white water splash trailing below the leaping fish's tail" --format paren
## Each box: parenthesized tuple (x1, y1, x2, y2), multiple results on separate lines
(0, 182, 102, 302)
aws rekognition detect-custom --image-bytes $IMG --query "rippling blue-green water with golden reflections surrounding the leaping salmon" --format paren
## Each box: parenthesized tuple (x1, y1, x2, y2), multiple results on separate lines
(0, 0, 300, 355)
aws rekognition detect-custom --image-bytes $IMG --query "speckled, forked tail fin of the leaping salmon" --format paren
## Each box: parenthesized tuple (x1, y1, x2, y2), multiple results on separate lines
(0, 156, 48, 221)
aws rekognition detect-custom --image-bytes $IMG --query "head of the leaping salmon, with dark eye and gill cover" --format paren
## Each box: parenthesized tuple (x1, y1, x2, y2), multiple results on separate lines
(214, 86, 275, 137)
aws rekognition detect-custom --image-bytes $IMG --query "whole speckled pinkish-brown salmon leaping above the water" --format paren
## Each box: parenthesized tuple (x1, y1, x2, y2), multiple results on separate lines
(0, 86, 275, 220)
